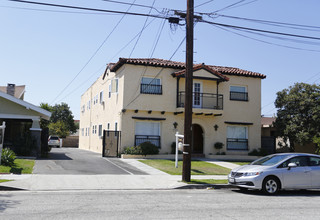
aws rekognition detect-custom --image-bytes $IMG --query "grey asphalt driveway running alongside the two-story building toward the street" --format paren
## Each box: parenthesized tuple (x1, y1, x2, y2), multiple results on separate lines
(33, 148, 147, 175)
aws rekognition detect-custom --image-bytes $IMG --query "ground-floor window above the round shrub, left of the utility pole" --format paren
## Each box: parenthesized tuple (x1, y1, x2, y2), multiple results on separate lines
(134, 121, 161, 147)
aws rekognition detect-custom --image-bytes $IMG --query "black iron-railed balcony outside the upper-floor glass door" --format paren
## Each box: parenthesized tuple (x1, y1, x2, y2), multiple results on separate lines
(177, 92, 223, 110)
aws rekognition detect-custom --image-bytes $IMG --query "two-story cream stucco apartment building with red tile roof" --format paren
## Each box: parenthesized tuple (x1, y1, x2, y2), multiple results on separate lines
(79, 58, 266, 155)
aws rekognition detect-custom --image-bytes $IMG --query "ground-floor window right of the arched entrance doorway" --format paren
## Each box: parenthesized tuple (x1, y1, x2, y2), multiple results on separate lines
(227, 126, 248, 150)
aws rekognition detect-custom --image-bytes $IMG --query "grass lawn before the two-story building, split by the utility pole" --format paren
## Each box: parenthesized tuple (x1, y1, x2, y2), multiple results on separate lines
(139, 160, 230, 175)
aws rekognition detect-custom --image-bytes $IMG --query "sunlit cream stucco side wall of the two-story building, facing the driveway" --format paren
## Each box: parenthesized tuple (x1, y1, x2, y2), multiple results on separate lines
(79, 70, 124, 153)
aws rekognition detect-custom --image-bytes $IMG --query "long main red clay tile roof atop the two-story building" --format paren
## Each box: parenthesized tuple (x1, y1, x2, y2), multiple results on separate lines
(110, 58, 266, 79)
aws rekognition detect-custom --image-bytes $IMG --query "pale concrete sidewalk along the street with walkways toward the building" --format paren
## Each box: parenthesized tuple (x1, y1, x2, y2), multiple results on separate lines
(0, 159, 238, 191)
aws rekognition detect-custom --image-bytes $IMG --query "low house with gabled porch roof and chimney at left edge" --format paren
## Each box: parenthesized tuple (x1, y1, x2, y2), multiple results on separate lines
(0, 84, 51, 155)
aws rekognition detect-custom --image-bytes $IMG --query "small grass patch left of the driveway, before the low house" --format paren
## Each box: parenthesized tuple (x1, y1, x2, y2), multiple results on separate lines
(0, 159, 34, 174)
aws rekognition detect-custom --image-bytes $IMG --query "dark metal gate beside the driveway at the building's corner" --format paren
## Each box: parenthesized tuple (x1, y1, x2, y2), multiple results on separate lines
(102, 130, 121, 157)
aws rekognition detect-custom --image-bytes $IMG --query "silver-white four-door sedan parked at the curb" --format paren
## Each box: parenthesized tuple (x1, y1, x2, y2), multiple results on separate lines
(228, 153, 320, 194)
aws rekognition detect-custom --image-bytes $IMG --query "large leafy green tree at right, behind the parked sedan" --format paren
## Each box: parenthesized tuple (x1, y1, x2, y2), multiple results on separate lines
(274, 83, 320, 150)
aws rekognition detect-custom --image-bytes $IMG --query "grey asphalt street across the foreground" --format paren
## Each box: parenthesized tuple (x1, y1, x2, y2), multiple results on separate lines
(0, 189, 320, 220)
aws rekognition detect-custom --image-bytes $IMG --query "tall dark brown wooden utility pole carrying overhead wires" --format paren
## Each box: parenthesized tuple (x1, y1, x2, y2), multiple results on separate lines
(182, 0, 194, 182)
